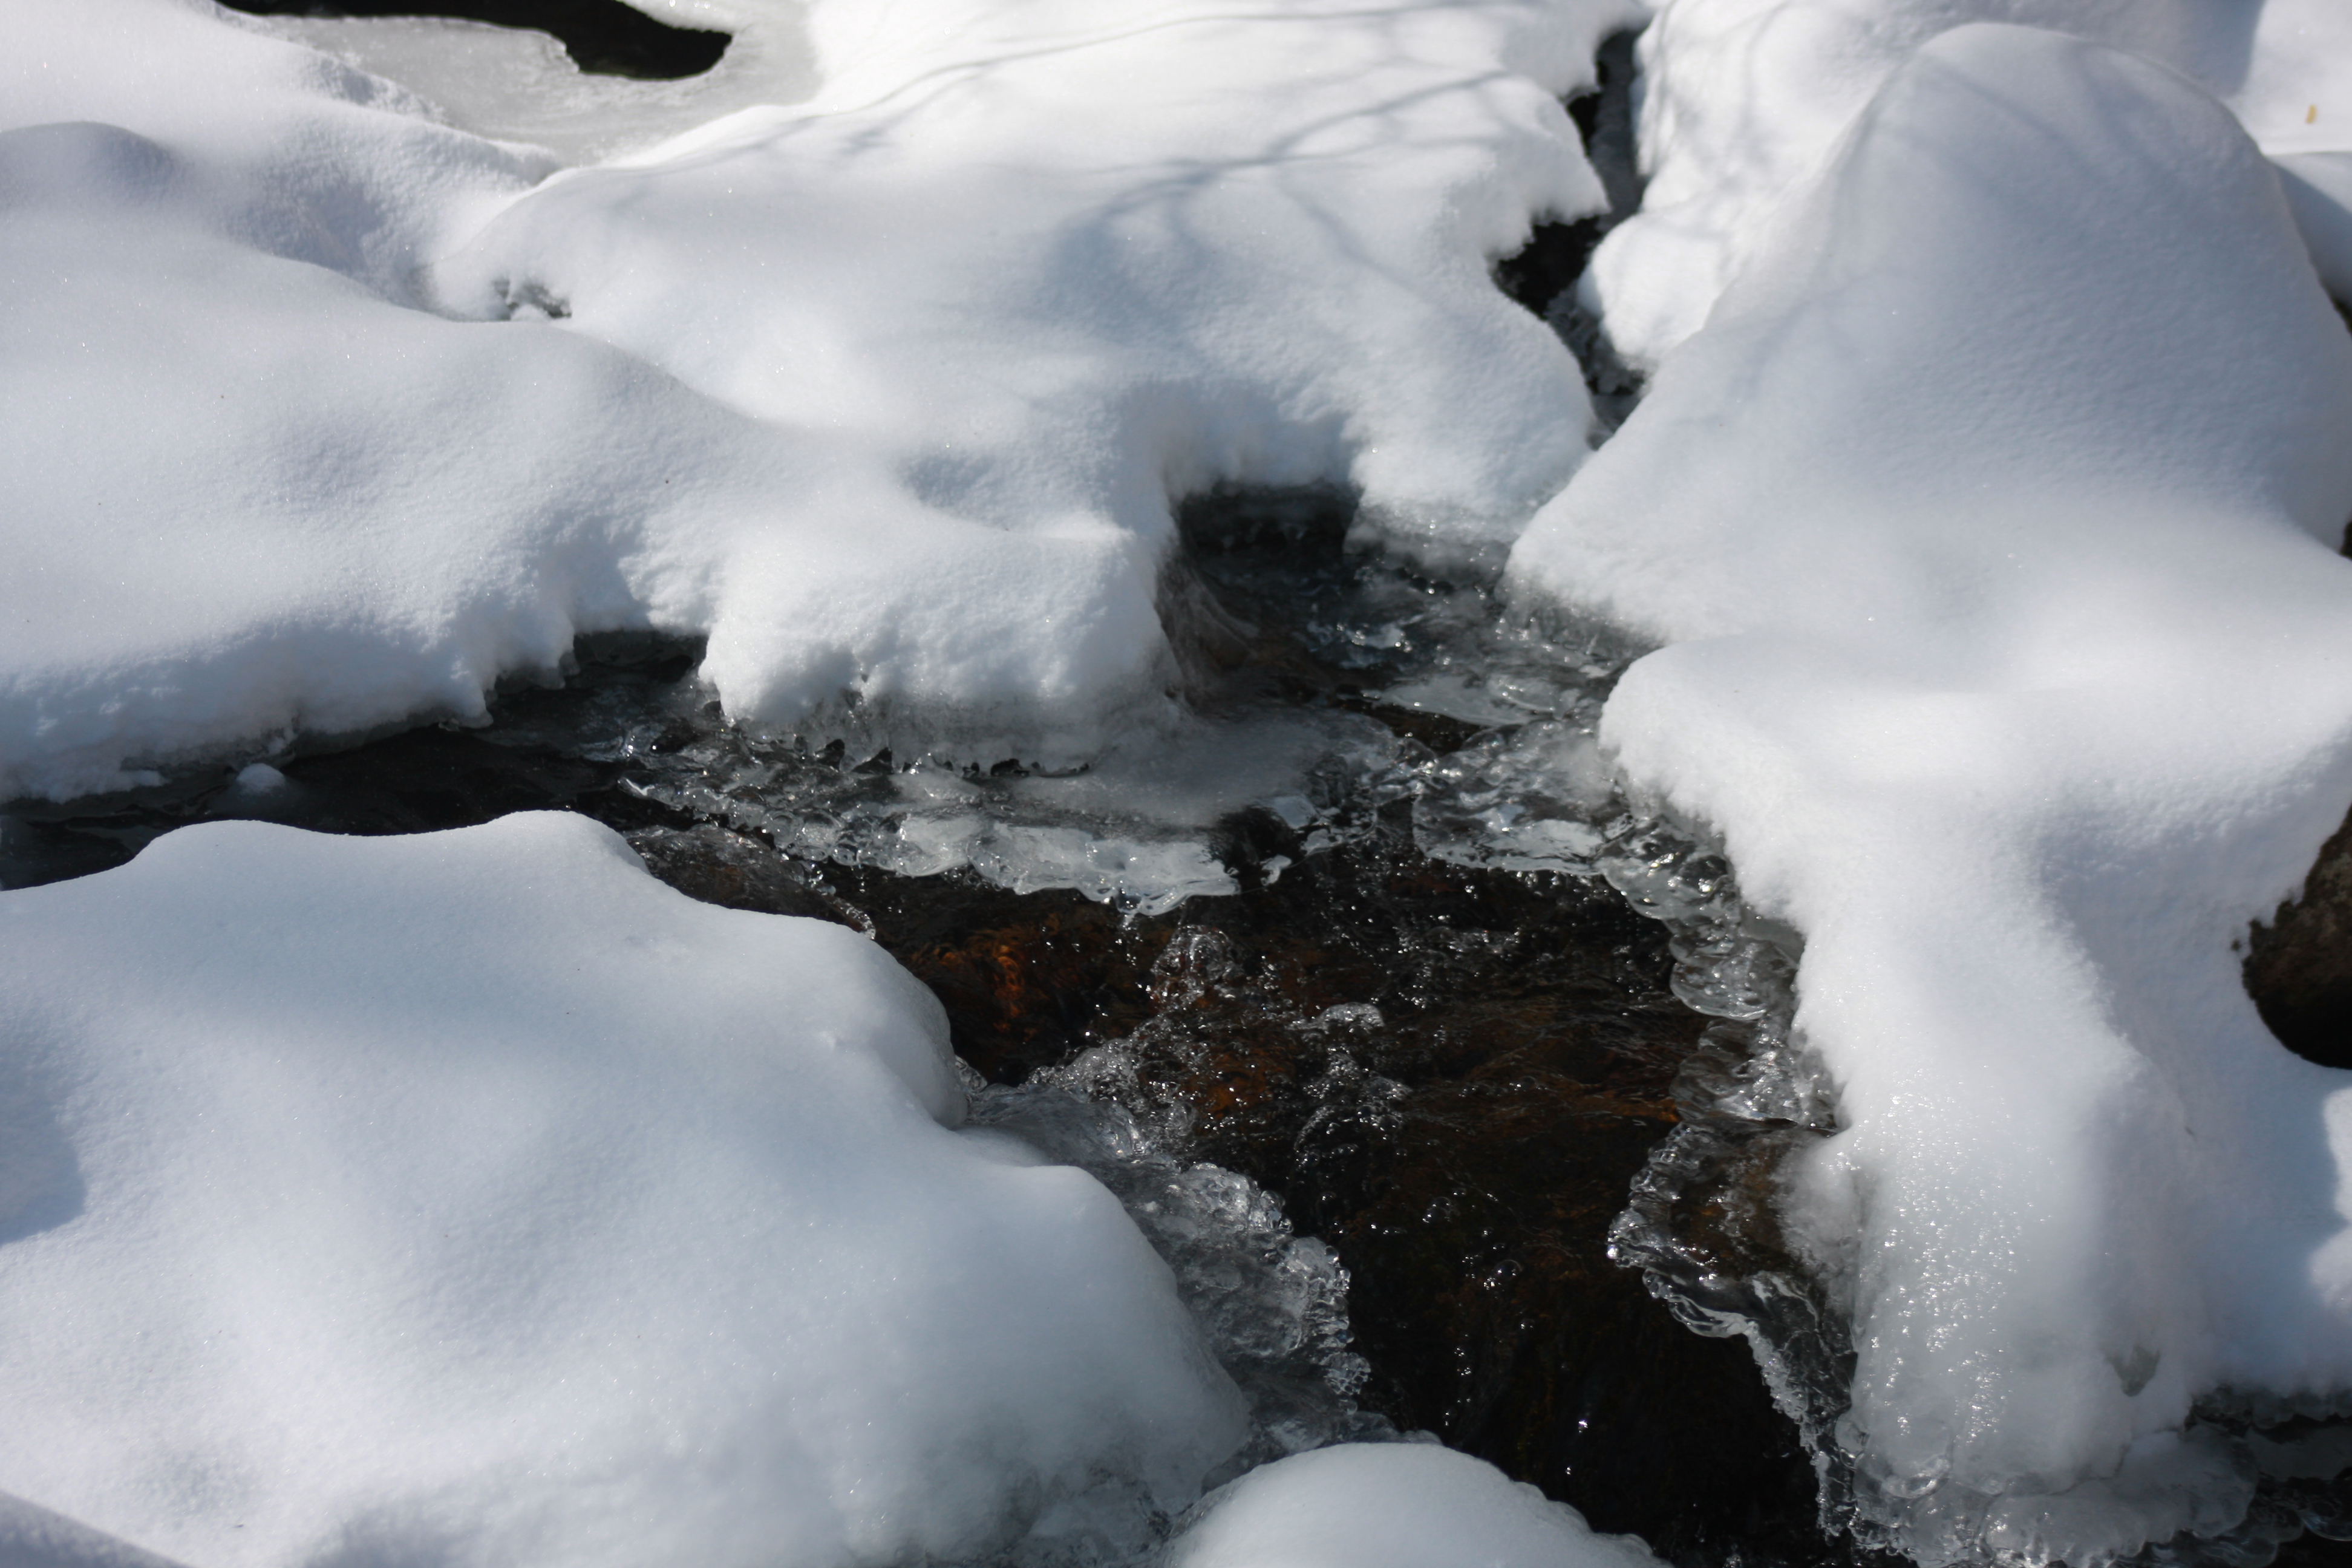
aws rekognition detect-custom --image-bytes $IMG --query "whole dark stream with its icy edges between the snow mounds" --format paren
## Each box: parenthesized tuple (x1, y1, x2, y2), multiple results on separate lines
(0, 7, 2352, 1568)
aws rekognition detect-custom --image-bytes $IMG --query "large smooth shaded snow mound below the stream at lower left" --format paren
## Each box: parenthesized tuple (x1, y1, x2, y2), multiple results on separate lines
(0, 815, 1242, 1568)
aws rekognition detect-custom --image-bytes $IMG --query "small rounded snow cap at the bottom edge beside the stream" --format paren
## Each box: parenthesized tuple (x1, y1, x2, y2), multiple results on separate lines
(1166, 1443, 1658, 1568)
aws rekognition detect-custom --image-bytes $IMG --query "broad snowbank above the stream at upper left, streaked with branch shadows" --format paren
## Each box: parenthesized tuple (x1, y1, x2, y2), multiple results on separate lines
(0, 0, 1632, 799)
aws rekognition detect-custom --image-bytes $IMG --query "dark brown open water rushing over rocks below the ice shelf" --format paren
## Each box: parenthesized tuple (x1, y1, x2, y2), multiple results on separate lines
(590, 802, 1834, 1566)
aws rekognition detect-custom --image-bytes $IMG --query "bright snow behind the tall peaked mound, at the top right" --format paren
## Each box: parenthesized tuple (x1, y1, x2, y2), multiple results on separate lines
(1581, 0, 2352, 367)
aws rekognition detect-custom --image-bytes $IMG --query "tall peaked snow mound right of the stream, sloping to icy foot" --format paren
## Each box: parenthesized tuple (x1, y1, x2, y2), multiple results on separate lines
(1512, 26, 2352, 1563)
